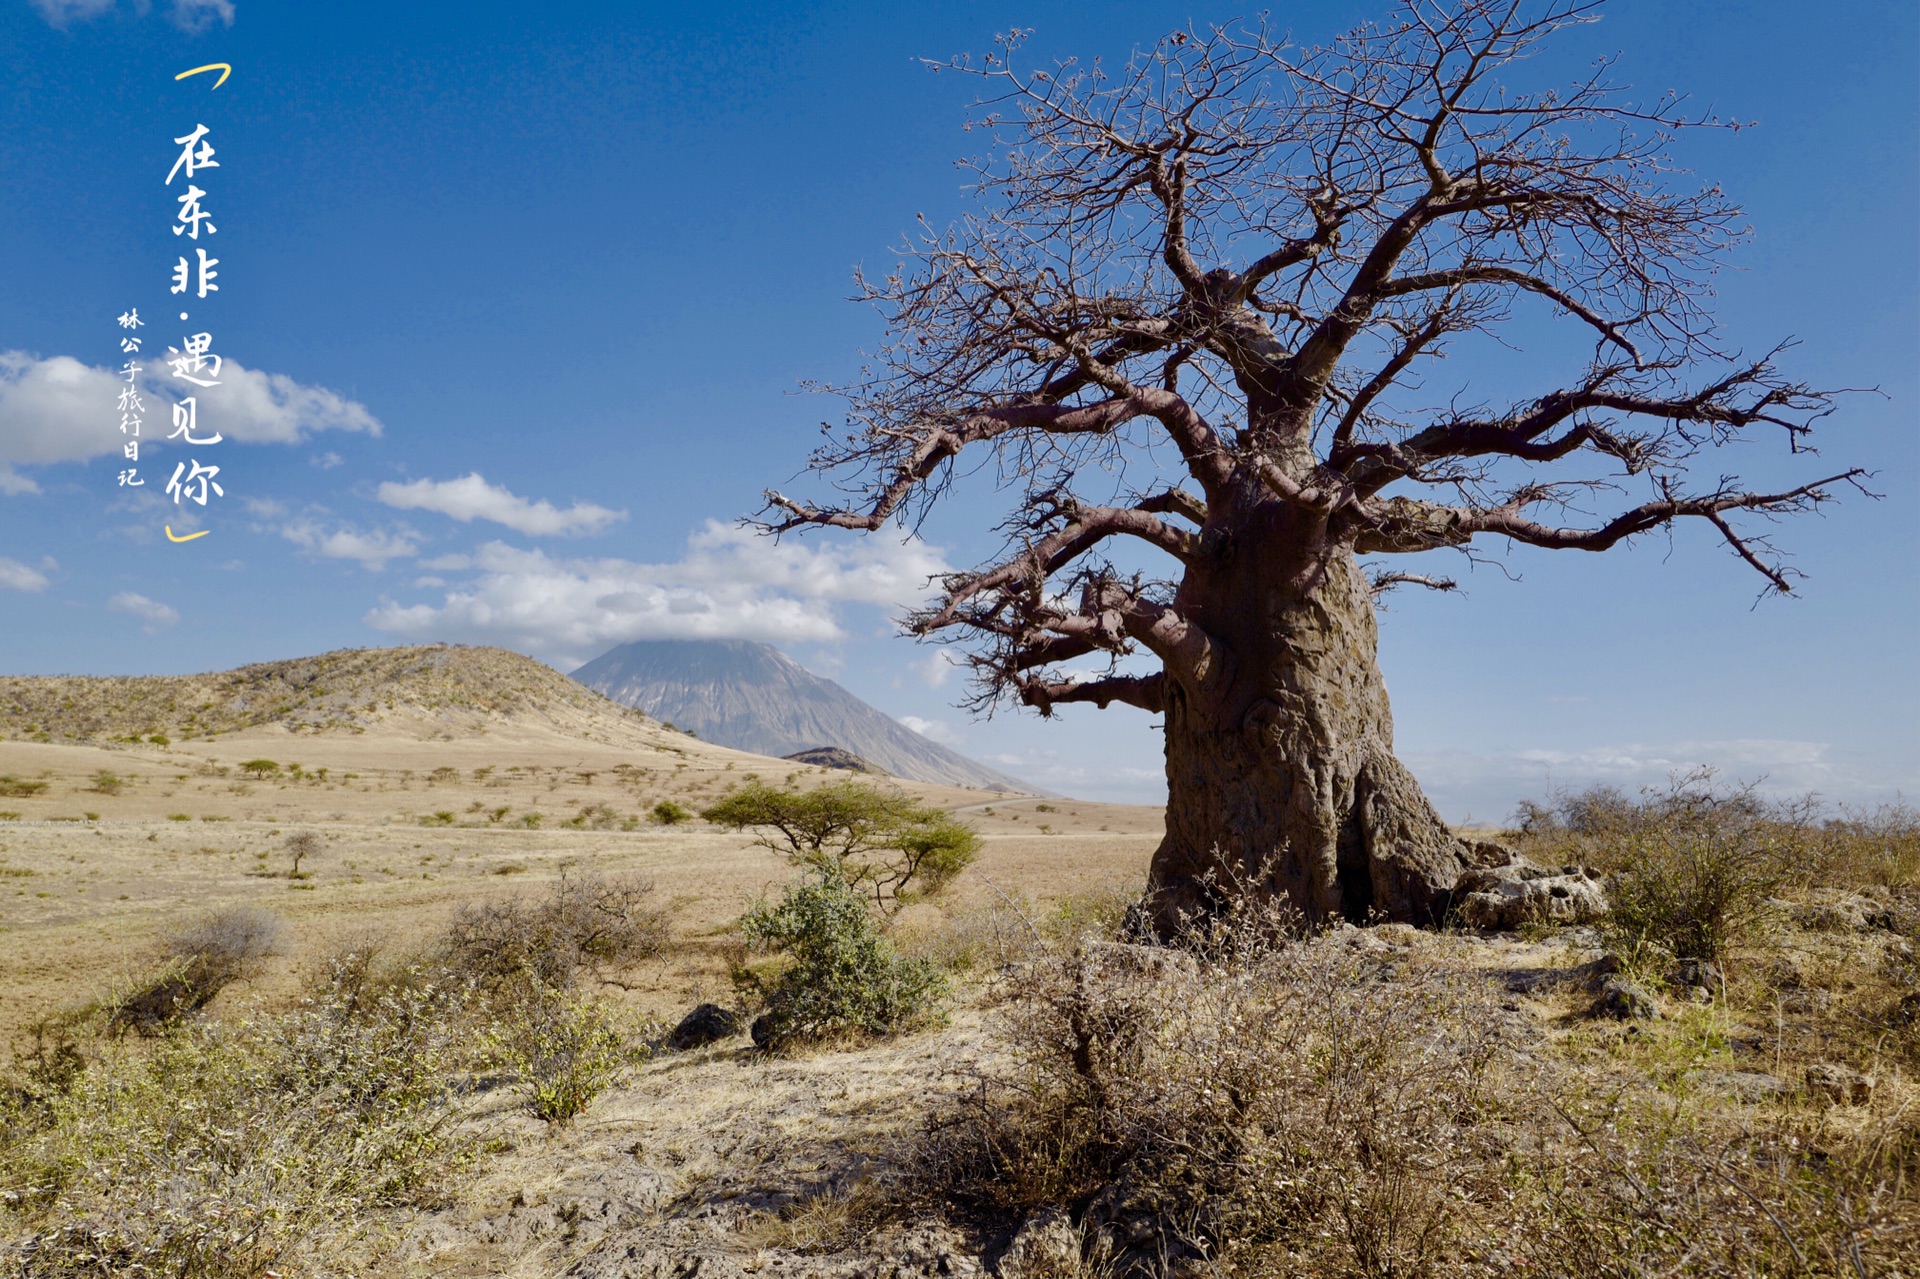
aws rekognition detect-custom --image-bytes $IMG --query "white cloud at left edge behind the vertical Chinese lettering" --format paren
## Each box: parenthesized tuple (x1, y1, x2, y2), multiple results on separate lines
(0, 351, 380, 494)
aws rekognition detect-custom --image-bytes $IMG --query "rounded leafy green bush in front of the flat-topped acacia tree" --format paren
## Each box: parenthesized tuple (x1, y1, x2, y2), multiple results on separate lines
(735, 866, 948, 1050)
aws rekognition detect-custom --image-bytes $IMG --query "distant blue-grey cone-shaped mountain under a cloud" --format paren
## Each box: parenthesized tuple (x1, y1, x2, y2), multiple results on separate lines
(572, 640, 1046, 795)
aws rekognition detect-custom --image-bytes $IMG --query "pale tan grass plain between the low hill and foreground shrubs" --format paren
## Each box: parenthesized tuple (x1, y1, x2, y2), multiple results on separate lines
(0, 724, 1162, 1041)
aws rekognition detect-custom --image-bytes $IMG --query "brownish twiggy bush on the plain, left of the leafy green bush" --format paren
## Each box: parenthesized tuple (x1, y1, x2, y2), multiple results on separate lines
(440, 872, 668, 991)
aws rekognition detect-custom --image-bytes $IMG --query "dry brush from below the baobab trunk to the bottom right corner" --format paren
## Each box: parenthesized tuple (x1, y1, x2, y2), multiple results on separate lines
(918, 887, 1920, 1279)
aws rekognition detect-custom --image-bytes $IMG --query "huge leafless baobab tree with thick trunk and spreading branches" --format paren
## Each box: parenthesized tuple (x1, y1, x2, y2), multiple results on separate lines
(760, 0, 1860, 928)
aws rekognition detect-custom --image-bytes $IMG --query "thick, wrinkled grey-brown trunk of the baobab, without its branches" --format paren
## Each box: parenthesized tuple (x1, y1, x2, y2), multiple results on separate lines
(1150, 514, 1471, 933)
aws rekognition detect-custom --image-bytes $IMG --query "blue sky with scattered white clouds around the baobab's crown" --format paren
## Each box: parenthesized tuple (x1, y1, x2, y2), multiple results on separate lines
(0, 0, 1920, 820)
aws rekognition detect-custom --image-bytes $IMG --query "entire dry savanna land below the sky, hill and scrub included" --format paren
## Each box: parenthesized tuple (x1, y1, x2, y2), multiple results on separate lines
(0, 647, 1920, 1279)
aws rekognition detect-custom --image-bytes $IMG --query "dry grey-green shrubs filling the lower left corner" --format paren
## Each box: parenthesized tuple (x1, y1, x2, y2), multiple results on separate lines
(0, 876, 664, 1279)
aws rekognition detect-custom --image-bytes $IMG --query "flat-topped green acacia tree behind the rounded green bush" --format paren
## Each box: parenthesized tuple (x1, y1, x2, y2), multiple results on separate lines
(701, 782, 979, 910)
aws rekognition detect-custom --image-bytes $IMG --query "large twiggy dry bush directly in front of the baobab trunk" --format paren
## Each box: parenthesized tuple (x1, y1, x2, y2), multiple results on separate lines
(929, 908, 1505, 1275)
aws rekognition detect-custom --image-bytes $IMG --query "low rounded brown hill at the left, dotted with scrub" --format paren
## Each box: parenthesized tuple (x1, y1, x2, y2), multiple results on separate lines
(0, 643, 675, 741)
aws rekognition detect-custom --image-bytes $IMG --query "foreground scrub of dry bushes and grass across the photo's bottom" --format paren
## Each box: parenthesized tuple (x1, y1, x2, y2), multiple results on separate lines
(0, 785, 1920, 1279)
